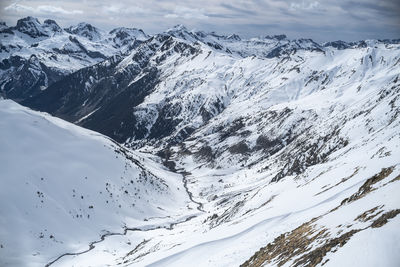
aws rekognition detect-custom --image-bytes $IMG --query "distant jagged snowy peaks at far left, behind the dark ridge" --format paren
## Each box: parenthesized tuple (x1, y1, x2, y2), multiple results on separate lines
(0, 17, 148, 101)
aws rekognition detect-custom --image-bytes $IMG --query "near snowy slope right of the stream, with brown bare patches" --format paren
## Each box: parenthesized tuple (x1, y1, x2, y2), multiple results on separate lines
(30, 66, 400, 267)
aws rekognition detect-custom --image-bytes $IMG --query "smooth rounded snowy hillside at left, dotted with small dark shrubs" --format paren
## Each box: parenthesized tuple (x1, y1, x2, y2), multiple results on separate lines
(0, 100, 195, 266)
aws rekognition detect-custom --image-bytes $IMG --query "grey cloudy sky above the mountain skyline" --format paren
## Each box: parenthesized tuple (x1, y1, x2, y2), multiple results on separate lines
(0, 0, 400, 41)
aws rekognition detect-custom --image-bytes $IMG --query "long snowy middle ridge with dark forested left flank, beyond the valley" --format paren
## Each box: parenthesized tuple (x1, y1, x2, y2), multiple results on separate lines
(24, 31, 400, 151)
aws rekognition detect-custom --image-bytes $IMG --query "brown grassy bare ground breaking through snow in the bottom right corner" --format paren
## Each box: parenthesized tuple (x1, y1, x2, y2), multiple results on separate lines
(240, 166, 400, 267)
